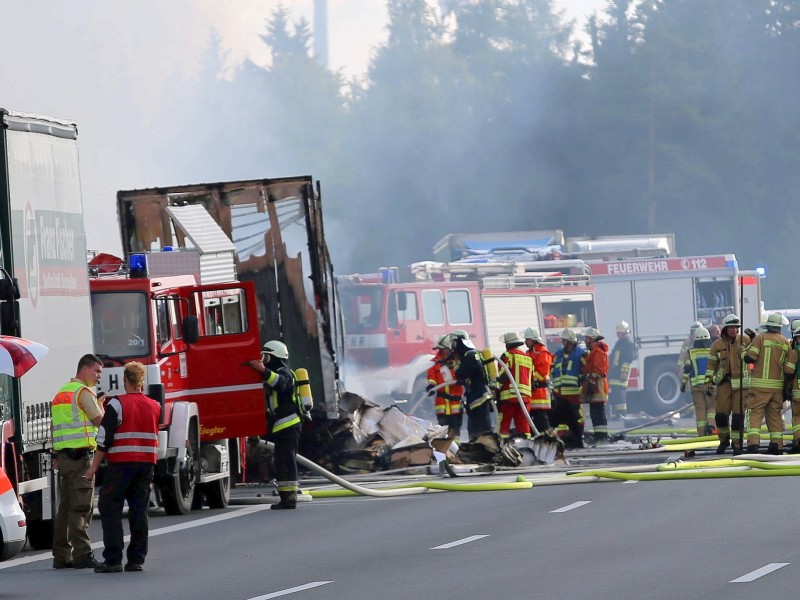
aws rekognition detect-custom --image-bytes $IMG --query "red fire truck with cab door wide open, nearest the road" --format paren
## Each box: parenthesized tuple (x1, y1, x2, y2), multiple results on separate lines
(89, 205, 266, 514)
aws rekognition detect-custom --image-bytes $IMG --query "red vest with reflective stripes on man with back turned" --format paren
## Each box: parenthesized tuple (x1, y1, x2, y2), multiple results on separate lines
(97, 393, 161, 464)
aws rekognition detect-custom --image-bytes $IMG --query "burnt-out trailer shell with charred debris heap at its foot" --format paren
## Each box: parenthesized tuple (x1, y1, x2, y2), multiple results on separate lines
(117, 176, 553, 482)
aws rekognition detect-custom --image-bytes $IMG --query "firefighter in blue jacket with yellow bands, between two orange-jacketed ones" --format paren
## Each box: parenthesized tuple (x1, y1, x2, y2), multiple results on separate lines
(551, 327, 586, 448)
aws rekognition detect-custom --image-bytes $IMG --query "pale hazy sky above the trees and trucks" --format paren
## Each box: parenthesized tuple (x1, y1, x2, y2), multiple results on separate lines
(0, 0, 604, 252)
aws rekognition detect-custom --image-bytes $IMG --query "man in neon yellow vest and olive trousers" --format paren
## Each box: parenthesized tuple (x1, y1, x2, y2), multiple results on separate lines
(50, 354, 103, 569)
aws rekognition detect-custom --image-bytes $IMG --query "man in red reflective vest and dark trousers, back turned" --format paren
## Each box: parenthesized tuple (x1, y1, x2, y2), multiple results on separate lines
(85, 362, 161, 573)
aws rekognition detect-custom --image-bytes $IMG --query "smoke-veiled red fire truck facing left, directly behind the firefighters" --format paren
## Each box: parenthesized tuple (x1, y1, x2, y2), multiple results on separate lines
(338, 260, 597, 417)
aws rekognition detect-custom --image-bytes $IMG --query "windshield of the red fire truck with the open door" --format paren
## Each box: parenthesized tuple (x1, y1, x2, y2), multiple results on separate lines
(92, 292, 150, 358)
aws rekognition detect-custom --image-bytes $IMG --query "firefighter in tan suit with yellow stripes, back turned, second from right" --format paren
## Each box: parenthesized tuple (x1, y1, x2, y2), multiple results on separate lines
(742, 313, 789, 455)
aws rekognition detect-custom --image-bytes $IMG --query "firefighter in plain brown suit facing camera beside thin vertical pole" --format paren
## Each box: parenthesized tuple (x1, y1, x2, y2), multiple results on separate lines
(705, 314, 750, 456)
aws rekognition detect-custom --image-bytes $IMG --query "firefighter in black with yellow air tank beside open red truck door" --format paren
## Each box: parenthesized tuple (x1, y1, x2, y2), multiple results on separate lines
(249, 340, 305, 510)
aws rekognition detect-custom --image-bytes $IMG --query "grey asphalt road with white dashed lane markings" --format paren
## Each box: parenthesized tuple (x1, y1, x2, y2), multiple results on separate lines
(0, 468, 800, 600)
